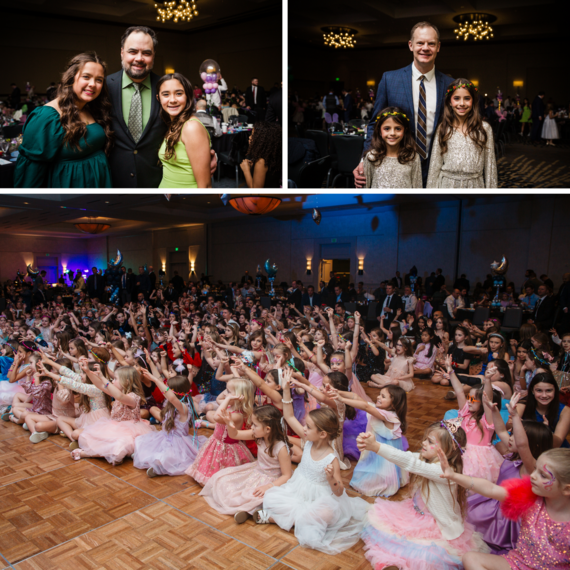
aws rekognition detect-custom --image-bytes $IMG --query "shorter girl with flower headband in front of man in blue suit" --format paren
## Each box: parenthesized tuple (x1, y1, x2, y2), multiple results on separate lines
(364, 107, 422, 188)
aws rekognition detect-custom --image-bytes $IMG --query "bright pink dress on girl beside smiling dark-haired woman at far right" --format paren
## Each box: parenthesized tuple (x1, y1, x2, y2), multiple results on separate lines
(459, 403, 504, 483)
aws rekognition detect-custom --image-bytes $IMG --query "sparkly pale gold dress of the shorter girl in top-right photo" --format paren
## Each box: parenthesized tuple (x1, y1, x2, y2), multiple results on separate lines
(364, 151, 423, 188)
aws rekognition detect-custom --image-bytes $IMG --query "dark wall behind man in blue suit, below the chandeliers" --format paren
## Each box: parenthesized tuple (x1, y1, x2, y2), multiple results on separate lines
(289, 40, 570, 104)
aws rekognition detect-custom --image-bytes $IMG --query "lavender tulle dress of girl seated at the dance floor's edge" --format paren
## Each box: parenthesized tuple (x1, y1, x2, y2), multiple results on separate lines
(133, 411, 208, 475)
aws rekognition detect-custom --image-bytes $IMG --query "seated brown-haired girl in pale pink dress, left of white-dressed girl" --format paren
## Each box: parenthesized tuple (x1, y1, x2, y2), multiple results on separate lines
(200, 406, 293, 524)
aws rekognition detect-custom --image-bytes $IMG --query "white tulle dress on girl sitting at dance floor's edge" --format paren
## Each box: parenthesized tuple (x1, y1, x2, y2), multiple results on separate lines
(263, 441, 371, 554)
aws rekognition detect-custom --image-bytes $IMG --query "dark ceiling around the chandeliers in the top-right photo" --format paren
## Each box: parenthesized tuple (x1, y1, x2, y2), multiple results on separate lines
(288, 0, 568, 52)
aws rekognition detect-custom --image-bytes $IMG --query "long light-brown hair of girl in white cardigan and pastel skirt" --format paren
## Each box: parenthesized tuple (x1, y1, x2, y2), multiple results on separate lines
(408, 422, 467, 519)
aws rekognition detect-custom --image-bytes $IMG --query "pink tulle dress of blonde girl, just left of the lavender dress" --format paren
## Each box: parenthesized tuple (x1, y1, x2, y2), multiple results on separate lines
(78, 392, 154, 465)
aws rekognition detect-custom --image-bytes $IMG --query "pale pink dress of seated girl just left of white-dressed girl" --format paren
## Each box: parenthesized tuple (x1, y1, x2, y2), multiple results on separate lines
(200, 440, 285, 515)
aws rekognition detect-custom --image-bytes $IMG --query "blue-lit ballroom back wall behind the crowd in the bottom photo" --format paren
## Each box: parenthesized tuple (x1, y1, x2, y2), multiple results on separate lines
(0, 195, 570, 289)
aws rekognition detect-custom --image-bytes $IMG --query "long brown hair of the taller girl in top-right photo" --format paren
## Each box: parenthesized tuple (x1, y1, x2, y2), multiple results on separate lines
(437, 78, 487, 155)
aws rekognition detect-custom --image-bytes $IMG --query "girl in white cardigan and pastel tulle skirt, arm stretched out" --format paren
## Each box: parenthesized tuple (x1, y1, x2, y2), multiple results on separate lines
(358, 421, 489, 570)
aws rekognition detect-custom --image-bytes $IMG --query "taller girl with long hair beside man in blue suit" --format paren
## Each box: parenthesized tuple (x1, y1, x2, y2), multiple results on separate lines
(427, 78, 497, 188)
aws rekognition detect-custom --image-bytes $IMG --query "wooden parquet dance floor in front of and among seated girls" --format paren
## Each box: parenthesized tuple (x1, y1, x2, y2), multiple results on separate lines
(0, 379, 455, 570)
